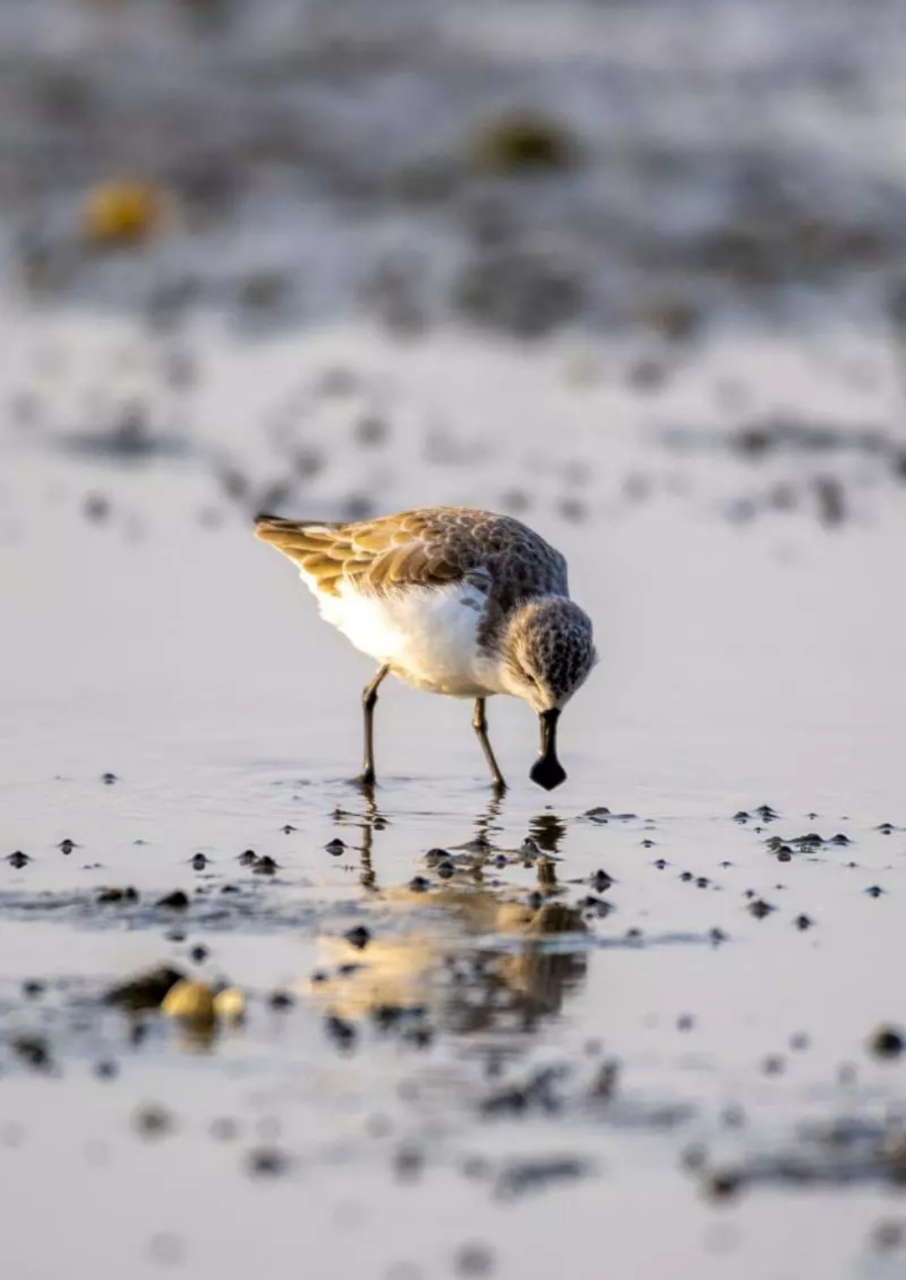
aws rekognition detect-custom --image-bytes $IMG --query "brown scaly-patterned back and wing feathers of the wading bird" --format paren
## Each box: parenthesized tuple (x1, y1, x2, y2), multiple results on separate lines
(255, 507, 568, 612)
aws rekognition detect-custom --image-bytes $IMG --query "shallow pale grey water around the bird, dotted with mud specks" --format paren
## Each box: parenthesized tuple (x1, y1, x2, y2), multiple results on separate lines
(0, 293, 906, 1280)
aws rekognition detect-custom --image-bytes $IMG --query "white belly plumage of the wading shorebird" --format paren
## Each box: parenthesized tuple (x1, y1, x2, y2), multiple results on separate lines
(303, 575, 504, 698)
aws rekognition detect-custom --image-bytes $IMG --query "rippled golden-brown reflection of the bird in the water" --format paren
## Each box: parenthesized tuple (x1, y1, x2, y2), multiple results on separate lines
(311, 794, 586, 1034)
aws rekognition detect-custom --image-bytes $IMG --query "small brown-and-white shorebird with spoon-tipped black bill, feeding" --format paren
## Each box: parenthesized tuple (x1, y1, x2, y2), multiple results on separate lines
(255, 507, 596, 791)
